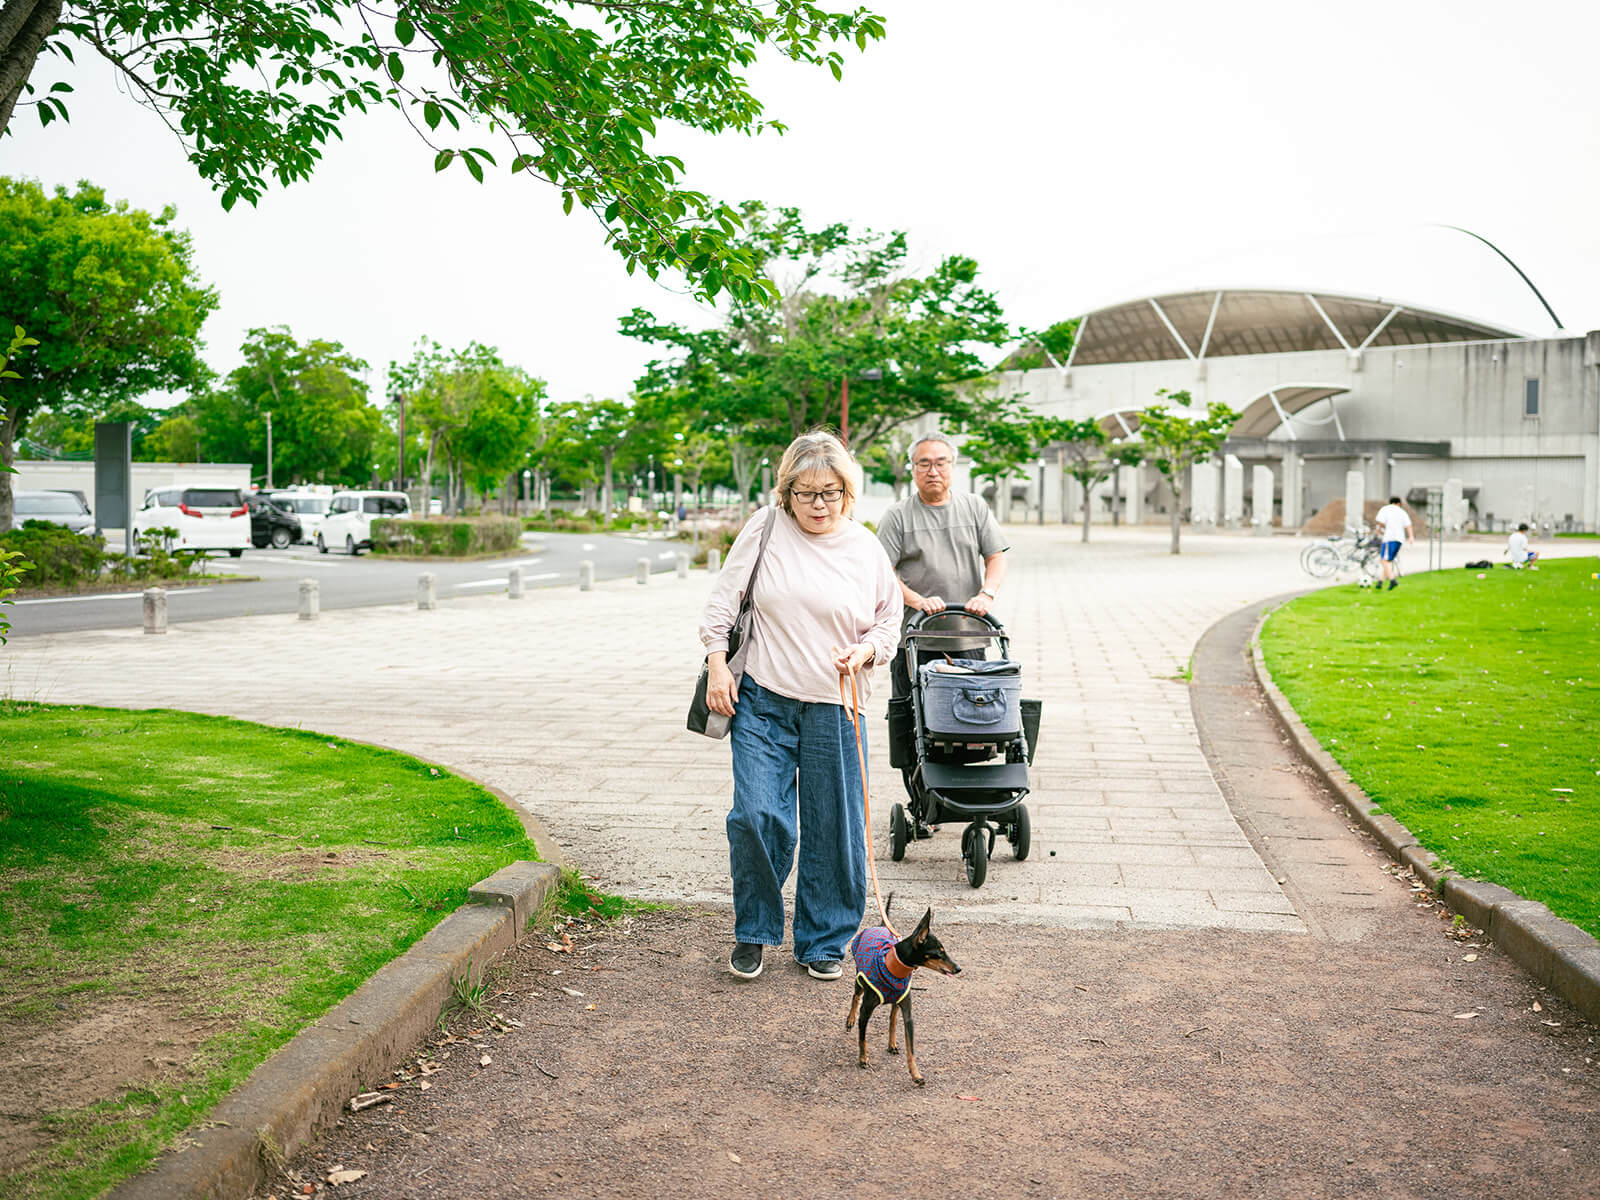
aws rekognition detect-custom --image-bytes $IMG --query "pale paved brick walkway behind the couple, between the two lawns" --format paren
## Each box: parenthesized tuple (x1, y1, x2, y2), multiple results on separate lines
(9, 526, 1587, 931)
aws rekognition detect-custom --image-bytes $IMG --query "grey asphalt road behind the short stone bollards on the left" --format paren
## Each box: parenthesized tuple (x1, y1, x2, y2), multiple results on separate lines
(6, 533, 691, 637)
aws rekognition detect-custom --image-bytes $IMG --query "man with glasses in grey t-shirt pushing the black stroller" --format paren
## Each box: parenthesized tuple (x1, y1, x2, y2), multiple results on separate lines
(878, 434, 1010, 835)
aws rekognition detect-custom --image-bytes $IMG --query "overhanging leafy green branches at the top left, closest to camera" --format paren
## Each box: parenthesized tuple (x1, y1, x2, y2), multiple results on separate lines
(0, 0, 883, 299)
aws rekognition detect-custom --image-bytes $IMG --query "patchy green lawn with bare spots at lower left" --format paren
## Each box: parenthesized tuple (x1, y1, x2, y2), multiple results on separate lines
(0, 704, 536, 1197)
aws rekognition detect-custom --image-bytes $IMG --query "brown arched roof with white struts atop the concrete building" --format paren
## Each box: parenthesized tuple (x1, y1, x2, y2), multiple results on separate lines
(1069, 288, 1523, 366)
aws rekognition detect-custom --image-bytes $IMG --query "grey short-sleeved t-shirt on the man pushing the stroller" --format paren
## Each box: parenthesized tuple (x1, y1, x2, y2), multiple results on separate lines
(878, 491, 1011, 650)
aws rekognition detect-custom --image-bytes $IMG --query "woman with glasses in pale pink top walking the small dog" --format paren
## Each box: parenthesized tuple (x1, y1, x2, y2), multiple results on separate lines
(701, 434, 901, 979)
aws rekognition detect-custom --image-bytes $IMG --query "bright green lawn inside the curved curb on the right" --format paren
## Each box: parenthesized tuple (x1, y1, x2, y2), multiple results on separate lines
(1261, 557, 1600, 934)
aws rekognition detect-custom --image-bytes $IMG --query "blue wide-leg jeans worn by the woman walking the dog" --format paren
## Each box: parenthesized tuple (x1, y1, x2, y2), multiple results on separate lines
(728, 677, 867, 963)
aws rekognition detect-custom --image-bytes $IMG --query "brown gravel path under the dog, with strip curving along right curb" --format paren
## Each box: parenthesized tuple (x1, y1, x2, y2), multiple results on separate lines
(243, 611, 1600, 1200)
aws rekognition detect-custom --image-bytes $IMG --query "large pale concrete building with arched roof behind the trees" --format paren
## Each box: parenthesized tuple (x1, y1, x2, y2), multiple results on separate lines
(998, 290, 1600, 530)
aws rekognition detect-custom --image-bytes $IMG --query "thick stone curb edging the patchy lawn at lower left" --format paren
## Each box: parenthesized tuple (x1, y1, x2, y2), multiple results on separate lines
(110, 862, 560, 1200)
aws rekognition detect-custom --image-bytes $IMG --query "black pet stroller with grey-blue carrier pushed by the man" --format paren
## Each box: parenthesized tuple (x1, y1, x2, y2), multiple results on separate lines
(890, 610, 1040, 888)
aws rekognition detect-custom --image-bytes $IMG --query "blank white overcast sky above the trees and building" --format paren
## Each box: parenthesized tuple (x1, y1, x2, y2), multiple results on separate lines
(0, 0, 1600, 412)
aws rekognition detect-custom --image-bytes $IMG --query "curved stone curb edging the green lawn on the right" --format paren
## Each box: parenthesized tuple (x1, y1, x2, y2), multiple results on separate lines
(1250, 602, 1600, 1021)
